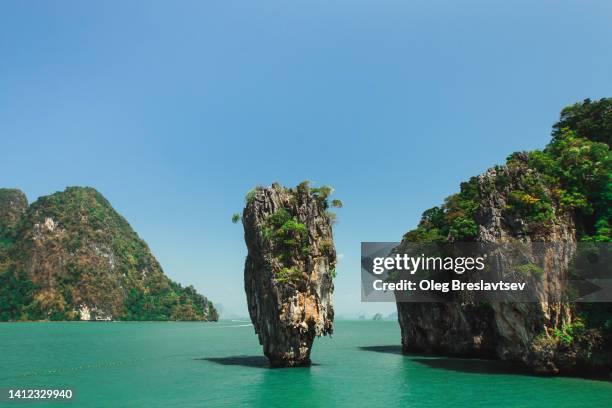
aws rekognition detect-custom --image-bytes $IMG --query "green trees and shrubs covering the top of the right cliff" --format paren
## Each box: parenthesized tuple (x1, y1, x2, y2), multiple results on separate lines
(405, 98, 612, 242)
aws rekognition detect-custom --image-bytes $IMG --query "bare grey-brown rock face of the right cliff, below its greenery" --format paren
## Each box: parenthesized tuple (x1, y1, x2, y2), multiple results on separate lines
(397, 157, 589, 374)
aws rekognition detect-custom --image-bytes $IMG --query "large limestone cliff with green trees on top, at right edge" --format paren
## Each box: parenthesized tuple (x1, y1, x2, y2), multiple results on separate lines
(397, 100, 612, 374)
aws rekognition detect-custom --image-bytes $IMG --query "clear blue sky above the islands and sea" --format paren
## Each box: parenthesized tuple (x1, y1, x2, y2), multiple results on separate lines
(0, 0, 612, 317)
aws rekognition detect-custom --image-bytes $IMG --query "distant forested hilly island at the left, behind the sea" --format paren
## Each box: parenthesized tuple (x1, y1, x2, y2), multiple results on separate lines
(0, 187, 218, 321)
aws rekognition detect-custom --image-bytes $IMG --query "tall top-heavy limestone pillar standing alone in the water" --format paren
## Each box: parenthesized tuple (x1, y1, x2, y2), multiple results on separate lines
(242, 184, 336, 367)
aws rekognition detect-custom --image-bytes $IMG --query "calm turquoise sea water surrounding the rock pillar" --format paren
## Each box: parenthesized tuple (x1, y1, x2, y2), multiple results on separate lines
(0, 321, 612, 408)
